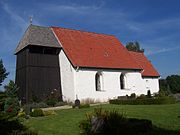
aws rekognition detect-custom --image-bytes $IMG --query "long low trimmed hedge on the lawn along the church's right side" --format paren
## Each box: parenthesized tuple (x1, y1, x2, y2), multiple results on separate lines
(109, 97, 176, 105)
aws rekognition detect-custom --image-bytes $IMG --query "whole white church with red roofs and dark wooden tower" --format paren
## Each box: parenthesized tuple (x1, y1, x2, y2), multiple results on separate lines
(15, 24, 160, 103)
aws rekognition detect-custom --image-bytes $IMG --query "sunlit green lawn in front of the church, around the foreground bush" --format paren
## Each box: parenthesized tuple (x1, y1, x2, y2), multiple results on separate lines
(25, 103, 180, 135)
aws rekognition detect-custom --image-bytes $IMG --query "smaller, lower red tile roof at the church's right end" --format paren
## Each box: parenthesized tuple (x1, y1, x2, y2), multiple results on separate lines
(129, 51, 160, 77)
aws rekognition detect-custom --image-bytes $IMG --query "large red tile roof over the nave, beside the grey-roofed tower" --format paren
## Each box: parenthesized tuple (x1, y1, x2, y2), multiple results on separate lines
(52, 27, 142, 69)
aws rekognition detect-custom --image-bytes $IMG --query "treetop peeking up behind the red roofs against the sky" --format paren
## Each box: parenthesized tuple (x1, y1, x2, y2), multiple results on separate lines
(126, 42, 144, 52)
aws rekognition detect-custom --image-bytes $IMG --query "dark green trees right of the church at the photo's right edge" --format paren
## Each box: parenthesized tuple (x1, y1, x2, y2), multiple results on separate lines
(159, 75, 180, 94)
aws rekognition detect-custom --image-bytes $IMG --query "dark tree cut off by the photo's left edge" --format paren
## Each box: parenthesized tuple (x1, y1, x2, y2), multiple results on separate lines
(0, 59, 9, 86)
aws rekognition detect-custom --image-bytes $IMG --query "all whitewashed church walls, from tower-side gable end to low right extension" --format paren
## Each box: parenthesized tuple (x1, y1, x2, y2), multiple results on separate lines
(59, 51, 159, 102)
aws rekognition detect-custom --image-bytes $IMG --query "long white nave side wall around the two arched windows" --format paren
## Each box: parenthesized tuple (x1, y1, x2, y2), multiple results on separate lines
(75, 69, 155, 102)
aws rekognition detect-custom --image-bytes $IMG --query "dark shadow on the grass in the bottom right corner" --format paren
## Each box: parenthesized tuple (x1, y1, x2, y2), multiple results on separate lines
(141, 127, 180, 135)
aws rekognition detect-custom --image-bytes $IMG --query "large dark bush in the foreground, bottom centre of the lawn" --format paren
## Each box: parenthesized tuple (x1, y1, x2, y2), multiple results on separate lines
(79, 108, 152, 135)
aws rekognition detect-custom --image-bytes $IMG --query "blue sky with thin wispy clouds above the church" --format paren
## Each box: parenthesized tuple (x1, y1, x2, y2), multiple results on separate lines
(0, 0, 180, 89)
